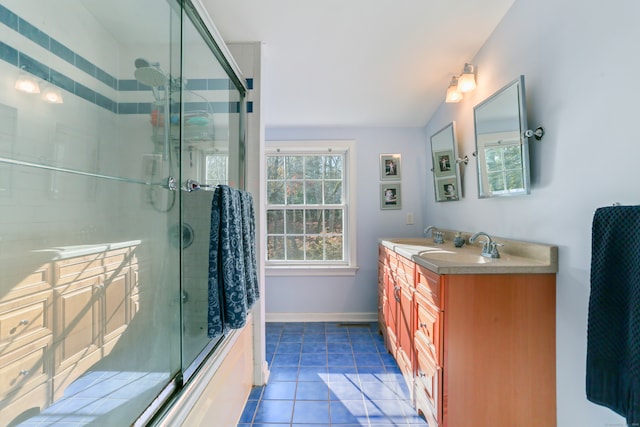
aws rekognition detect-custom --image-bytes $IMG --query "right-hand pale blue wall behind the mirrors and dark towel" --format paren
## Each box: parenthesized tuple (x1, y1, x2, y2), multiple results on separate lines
(423, 0, 640, 427)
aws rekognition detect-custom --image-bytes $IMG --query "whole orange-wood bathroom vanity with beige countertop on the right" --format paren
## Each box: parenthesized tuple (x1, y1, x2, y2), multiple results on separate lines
(378, 231, 558, 427)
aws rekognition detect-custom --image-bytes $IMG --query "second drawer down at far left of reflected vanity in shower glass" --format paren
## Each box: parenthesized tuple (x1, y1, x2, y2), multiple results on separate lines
(0, 291, 53, 353)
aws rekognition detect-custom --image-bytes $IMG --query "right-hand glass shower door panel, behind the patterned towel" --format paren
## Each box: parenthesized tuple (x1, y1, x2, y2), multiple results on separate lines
(181, 3, 249, 379)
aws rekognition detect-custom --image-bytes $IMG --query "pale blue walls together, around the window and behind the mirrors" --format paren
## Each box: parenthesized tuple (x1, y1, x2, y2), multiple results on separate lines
(266, 0, 640, 427)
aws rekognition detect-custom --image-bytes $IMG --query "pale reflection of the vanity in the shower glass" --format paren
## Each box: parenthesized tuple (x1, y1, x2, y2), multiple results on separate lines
(0, 240, 140, 421)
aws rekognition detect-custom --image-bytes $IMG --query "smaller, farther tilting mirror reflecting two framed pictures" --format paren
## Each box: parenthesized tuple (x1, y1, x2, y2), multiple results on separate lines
(431, 122, 460, 202)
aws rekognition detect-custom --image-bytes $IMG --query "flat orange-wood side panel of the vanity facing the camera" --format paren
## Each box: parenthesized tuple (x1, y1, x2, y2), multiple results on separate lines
(441, 274, 556, 427)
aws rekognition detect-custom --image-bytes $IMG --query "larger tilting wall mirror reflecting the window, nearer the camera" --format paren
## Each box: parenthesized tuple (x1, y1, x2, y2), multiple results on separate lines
(473, 76, 530, 198)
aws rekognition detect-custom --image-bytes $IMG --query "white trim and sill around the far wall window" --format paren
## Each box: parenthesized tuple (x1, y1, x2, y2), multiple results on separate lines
(262, 140, 358, 276)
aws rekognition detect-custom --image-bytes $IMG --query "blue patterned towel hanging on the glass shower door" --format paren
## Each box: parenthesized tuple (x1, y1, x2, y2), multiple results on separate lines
(208, 185, 259, 338)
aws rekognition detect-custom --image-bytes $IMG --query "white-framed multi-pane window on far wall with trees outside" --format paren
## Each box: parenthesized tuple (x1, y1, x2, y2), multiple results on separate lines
(265, 141, 355, 274)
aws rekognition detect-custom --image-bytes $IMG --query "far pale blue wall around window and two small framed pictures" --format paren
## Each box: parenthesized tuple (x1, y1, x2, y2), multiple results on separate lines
(265, 127, 433, 320)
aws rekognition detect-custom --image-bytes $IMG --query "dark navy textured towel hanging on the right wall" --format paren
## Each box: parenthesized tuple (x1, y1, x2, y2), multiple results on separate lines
(586, 206, 640, 426)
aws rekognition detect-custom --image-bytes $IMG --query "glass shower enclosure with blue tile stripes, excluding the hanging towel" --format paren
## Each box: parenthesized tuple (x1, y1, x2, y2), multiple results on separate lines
(0, 0, 246, 426)
